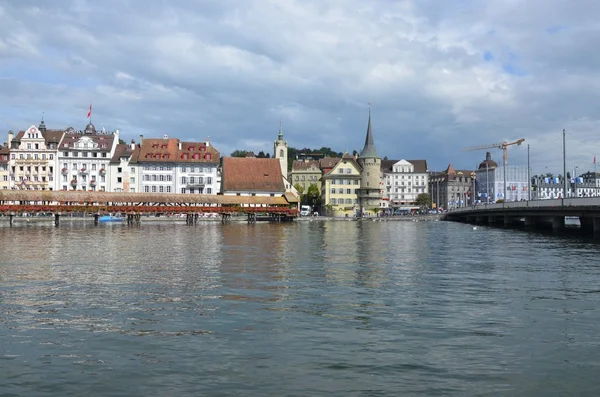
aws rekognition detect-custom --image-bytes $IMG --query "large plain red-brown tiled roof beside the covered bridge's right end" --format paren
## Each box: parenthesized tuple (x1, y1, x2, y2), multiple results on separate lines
(222, 157, 285, 194)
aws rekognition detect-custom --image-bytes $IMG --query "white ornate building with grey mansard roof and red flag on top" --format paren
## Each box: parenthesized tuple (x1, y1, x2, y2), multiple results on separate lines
(57, 123, 119, 192)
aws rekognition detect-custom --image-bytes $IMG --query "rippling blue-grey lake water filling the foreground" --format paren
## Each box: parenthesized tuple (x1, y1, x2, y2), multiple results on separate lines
(0, 221, 600, 396)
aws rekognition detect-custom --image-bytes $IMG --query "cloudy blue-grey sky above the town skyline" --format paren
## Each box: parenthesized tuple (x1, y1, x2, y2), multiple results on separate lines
(0, 0, 600, 173)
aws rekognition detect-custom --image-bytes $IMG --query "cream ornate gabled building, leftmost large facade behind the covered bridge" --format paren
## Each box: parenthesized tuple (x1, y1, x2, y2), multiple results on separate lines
(8, 121, 64, 190)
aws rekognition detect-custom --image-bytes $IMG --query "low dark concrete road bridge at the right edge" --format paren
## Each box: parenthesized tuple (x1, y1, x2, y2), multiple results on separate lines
(443, 197, 600, 237)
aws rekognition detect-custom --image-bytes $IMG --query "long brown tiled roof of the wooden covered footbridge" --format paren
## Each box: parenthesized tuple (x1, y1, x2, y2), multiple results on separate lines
(0, 190, 290, 205)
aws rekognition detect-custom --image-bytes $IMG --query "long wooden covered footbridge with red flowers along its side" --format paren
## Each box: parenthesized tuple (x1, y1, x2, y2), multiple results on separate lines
(0, 190, 298, 224)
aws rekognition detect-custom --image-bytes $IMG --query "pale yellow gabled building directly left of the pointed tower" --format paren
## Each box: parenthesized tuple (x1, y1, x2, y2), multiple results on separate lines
(321, 153, 362, 217)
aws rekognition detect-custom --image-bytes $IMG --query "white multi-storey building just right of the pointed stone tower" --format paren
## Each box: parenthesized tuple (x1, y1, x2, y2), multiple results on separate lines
(381, 160, 429, 208)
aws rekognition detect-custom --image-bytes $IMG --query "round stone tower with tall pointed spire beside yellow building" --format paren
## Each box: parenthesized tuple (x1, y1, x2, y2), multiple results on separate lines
(358, 106, 381, 215)
